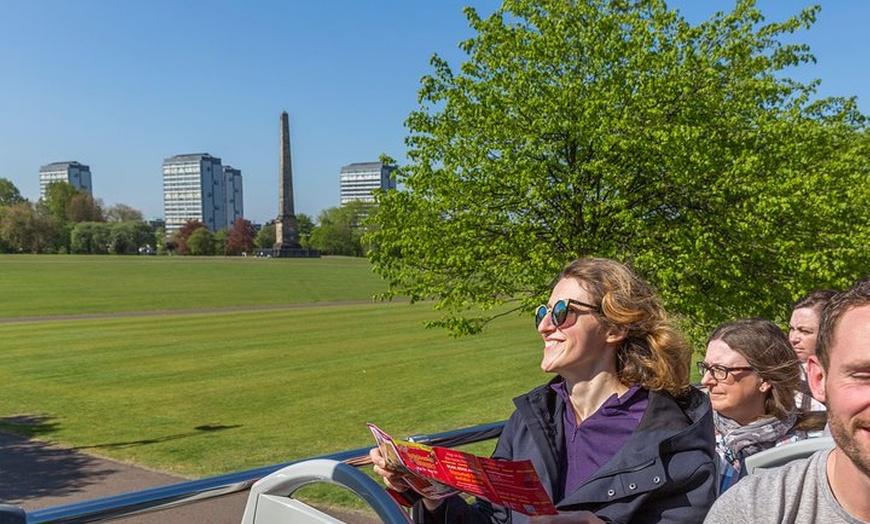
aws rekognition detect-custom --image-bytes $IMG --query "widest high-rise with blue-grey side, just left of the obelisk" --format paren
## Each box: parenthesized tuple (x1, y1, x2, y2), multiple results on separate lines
(163, 153, 244, 233)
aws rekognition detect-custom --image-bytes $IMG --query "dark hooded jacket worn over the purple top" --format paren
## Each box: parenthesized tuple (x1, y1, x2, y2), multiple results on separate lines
(413, 377, 717, 524)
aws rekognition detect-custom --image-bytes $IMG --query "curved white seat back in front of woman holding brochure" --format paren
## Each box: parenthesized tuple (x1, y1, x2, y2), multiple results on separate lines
(242, 459, 411, 524)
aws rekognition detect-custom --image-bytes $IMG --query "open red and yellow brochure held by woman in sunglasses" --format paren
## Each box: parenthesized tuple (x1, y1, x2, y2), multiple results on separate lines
(368, 424, 558, 515)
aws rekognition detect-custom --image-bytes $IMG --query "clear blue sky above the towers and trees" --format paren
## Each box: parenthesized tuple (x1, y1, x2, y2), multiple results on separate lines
(0, 0, 870, 223)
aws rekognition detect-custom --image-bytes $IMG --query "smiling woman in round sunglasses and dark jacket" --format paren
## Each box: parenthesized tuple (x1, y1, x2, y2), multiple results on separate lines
(370, 258, 717, 524)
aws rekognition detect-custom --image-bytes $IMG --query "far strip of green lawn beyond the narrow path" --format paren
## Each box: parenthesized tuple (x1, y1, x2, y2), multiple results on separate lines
(0, 255, 385, 318)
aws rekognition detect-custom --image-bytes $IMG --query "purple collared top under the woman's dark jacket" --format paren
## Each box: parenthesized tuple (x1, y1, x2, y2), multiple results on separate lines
(550, 382, 649, 494)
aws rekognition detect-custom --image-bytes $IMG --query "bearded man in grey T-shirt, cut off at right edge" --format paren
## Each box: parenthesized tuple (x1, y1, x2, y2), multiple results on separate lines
(705, 281, 870, 524)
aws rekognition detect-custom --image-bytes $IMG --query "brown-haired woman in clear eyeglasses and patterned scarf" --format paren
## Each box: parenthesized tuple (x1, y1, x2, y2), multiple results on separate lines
(698, 319, 807, 492)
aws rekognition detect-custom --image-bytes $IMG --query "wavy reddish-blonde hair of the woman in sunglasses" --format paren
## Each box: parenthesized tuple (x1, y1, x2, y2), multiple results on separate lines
(559, 258, 692, 396)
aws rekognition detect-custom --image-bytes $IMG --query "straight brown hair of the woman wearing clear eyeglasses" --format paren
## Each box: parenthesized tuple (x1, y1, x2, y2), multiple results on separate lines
(707, 318, 801, 420)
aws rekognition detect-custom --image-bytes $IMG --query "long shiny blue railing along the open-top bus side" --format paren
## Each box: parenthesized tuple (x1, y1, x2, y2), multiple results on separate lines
(27, 422, 505, 524)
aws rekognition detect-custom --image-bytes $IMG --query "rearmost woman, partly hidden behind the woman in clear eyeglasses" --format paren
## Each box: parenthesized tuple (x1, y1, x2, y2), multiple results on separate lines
(788, 289, 837, 411)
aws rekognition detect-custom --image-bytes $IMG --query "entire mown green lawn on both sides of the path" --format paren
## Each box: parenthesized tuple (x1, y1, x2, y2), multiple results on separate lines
(0, 255, 547, 484)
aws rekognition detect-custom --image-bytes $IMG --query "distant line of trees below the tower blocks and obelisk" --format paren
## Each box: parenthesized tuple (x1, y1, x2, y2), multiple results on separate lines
(0, 178, 372, 256)
